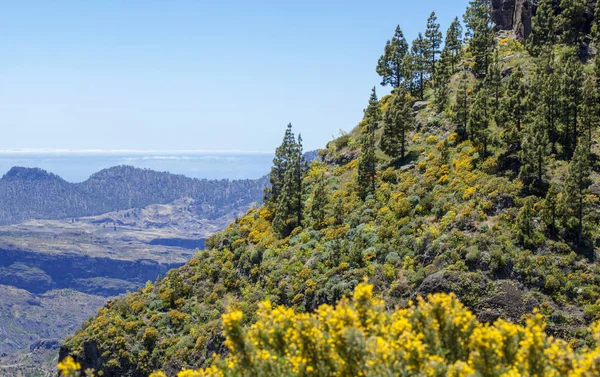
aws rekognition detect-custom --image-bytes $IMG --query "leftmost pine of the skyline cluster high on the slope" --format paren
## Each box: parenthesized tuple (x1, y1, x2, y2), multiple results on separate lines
(376, 25, 408, 88)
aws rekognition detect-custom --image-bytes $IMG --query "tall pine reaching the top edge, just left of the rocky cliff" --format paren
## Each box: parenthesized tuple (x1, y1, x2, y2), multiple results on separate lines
(464, 0, 496, 77)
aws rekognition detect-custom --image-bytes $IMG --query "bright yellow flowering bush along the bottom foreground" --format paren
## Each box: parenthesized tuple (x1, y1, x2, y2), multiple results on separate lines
(59, 284, 600, 377)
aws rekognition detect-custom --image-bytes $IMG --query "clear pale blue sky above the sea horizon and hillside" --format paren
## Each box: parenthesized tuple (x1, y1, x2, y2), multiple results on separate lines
(0, 0, 468, 151)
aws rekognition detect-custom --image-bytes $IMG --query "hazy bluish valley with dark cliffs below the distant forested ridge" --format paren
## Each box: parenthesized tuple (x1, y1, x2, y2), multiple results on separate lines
(0, 169, 262, 376)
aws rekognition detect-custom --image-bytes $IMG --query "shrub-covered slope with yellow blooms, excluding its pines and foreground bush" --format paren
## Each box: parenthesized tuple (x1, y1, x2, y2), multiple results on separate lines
(61, 32, 600, 376)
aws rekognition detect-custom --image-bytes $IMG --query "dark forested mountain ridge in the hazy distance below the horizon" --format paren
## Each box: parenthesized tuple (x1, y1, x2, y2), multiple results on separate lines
(0, 166, 268, 225)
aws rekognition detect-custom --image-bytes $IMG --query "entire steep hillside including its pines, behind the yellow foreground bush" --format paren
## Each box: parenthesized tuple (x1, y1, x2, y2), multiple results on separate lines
(62, 0, 600, 376)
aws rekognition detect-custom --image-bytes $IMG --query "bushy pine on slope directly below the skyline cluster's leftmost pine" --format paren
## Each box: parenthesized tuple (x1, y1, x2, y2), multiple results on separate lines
(381, 91, 414, 161)
